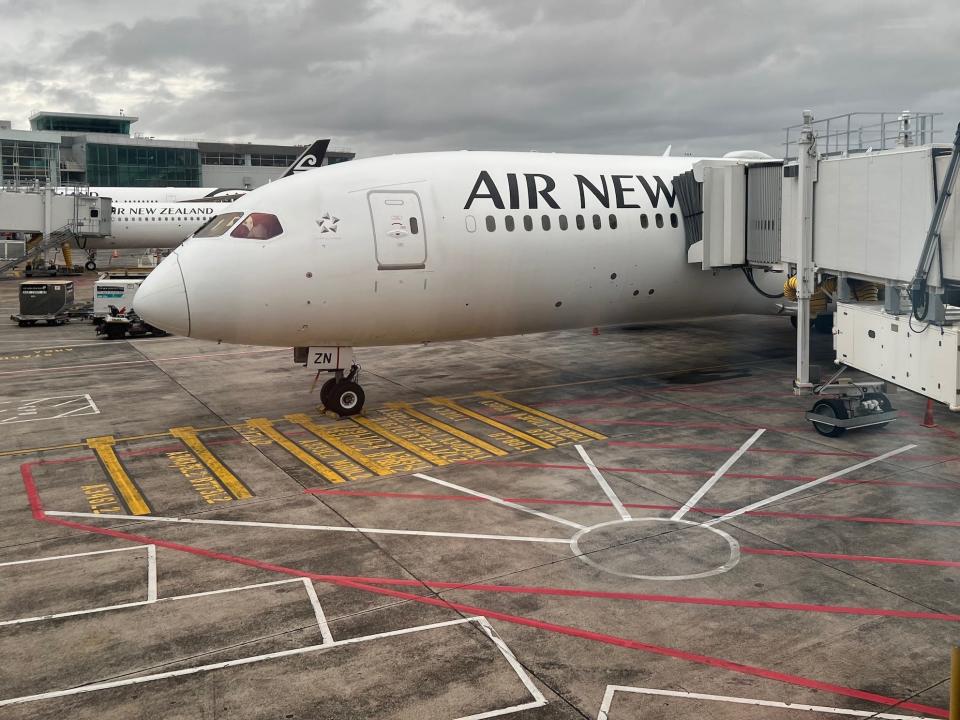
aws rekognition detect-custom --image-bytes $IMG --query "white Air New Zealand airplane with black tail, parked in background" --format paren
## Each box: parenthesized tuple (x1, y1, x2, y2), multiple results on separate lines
(68, 139, 330, 270)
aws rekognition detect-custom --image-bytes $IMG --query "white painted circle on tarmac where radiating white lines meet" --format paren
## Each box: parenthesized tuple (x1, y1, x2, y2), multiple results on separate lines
(570, 518, 740, 580)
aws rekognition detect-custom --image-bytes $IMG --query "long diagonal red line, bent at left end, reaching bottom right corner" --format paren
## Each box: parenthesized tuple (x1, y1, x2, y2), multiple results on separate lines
(21, 466, 949, 717)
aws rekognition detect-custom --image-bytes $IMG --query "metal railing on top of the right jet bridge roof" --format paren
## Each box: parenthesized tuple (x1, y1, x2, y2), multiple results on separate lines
(783, 110, 943, 159)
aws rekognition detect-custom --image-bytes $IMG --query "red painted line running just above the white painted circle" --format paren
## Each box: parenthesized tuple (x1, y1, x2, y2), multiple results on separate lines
(304, 488, 960, 527)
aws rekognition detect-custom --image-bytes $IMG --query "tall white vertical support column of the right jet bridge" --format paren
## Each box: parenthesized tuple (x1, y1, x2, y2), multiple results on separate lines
(793, 110, 817, 395)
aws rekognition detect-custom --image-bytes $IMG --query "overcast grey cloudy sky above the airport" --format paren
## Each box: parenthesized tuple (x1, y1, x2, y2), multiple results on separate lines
(0, 0, 960, 156)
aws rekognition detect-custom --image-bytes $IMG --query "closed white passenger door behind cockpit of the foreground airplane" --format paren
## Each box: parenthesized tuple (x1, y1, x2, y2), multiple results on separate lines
(367, 190, 427, 270)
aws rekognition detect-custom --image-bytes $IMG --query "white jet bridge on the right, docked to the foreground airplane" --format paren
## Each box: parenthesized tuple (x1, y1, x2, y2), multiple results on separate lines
(675, 112, 960, 435)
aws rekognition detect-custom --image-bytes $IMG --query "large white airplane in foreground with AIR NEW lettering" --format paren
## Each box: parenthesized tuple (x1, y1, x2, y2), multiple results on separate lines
(135, 151, 782, 416)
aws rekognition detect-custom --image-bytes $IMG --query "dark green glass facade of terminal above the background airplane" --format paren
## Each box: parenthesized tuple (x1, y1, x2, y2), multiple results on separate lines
(87, 143, 200, 187)
